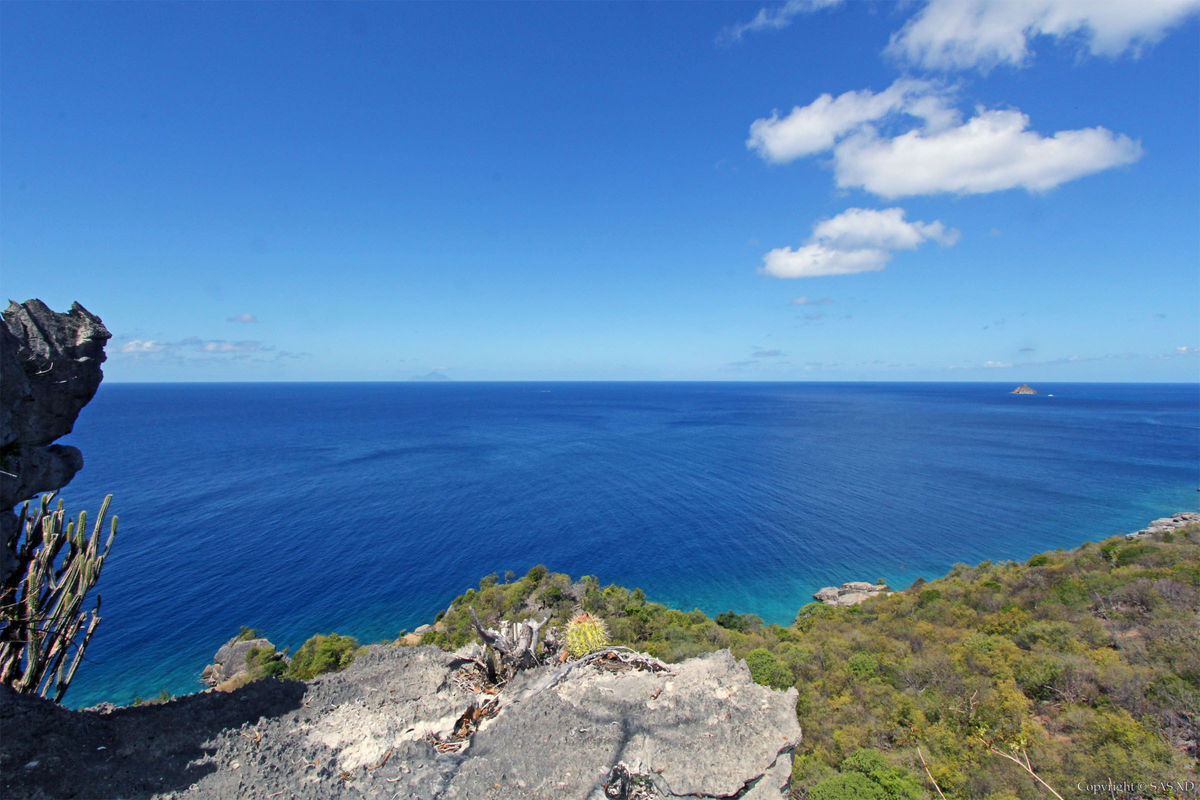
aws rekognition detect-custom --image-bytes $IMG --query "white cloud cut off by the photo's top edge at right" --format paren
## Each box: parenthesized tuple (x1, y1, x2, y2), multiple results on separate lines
(887, 0, 1200, 70)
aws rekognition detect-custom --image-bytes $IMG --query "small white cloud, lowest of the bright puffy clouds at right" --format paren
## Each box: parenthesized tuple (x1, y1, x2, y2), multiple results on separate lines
(762, 209, 959, 278)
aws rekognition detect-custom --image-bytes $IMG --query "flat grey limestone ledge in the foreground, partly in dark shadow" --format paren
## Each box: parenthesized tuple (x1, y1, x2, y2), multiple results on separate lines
(0, 645, 800, 800)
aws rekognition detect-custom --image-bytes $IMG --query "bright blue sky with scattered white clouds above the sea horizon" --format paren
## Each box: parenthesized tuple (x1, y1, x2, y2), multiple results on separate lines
(0, 0, 1200, 383)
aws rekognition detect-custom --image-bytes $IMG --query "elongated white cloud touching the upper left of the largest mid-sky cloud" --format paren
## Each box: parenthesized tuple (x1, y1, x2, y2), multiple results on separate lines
(746, 78, 958, 163)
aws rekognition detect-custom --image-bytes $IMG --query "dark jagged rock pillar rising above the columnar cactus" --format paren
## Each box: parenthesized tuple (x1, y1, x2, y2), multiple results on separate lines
(0, 300, 112, 581)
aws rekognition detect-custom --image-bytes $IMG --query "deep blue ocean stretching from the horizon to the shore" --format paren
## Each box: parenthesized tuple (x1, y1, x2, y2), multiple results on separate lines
(42, 383, 1200, 706)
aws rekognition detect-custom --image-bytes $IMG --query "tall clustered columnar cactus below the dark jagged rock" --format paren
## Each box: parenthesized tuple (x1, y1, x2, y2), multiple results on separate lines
(0, 494, 116, 702)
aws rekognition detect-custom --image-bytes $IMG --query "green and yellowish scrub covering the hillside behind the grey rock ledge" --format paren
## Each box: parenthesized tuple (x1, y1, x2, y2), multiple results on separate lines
(422, 527, 1200, 800)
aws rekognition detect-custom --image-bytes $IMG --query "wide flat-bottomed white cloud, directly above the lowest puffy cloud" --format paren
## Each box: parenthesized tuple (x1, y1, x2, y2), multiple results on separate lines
(834, 109, 1141, 198)
